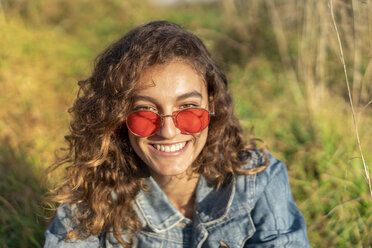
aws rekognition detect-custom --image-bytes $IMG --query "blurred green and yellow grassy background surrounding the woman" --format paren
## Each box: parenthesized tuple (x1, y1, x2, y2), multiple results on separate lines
(0, 0, 372, 247)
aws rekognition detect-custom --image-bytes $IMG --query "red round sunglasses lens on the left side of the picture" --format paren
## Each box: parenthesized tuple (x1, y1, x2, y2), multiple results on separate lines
(126, 111, 161, 136)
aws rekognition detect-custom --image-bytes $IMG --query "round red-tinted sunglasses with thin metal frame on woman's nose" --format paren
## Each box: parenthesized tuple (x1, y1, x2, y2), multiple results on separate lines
(125, 108, 214, 137)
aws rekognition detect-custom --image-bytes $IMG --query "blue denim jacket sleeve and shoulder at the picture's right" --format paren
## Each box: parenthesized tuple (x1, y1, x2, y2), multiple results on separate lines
(235, 151, 310, 247)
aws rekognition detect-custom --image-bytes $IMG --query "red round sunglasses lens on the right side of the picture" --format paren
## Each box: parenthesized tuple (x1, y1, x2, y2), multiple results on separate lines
(177, 108, 209, 133)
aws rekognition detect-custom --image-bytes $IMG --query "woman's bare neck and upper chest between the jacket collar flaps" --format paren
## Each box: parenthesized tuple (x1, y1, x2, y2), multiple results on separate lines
(153, 170, 200, 219)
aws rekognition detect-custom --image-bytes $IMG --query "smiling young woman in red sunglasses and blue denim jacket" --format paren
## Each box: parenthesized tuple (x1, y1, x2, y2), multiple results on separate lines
(45, 21, 309, 248)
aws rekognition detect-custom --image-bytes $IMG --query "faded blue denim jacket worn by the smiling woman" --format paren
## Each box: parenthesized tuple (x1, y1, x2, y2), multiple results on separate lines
(44, 151, 310, 248)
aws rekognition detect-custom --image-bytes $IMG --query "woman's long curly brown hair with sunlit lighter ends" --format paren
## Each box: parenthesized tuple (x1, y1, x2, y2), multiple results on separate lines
(46, 21, 267, 247)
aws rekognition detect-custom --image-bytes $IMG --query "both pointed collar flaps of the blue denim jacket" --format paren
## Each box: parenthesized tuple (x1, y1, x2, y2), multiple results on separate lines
(136, 172, 235, 233)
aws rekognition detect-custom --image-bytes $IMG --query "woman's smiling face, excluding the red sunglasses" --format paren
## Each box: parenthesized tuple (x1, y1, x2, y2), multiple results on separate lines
(128, 60, 208, 177)
